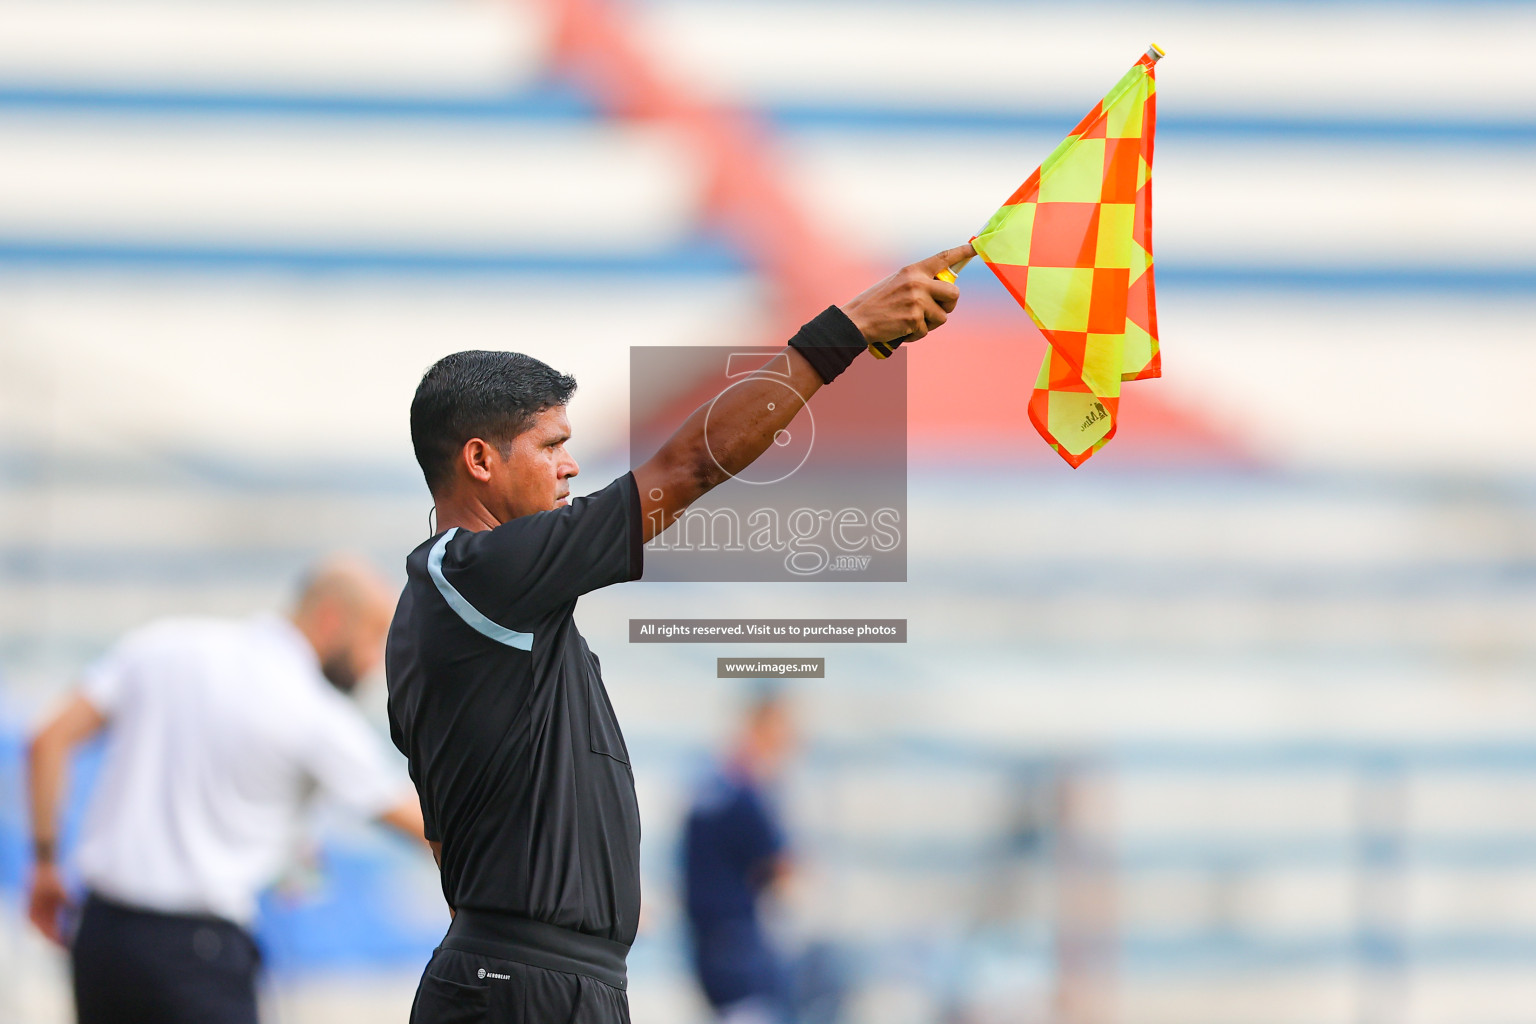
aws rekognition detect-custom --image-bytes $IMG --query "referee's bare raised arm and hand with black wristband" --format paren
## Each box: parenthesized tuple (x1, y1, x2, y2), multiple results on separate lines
(634, 243, 975, 540)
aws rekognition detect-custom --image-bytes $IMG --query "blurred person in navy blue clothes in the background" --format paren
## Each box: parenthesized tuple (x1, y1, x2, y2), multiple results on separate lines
(682, 689, 794, 1024)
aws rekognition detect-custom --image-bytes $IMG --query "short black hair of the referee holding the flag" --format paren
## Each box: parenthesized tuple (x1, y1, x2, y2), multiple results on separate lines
(410, 352, 576, 491)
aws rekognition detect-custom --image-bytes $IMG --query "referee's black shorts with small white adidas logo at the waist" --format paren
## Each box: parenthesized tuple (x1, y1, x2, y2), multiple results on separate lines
(410, 947, 630, 1024)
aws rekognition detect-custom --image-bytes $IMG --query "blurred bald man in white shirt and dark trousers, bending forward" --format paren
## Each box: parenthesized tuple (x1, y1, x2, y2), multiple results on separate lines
(28, 559, 425, 1024)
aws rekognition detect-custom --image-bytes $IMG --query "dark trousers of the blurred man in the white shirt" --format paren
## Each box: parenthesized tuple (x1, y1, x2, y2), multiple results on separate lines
(71, 895, 261, 1024)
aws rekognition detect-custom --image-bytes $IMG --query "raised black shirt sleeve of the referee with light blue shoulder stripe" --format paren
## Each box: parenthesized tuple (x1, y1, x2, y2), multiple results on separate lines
(429, 473, 644, 629)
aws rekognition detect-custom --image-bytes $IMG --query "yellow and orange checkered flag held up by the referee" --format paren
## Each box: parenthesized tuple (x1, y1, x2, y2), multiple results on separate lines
(972, 45, 1163, 468)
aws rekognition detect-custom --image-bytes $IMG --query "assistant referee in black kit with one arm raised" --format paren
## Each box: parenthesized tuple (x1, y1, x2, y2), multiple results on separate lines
(386, 246, 974, 1024)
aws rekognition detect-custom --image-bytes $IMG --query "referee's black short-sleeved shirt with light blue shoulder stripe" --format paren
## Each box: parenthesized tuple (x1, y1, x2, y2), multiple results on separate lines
(386, 474, 642, 944)
